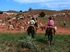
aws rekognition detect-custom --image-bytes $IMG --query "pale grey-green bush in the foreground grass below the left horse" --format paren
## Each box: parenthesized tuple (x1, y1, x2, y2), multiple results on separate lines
(17, 36, 37, 52)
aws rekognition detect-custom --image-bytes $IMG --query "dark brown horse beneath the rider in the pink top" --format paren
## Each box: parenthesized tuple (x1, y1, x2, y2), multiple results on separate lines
(45, 26, 56, 45)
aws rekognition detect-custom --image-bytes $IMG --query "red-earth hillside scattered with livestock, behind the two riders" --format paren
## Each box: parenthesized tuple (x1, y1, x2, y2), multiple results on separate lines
(0, 9, 70, 34)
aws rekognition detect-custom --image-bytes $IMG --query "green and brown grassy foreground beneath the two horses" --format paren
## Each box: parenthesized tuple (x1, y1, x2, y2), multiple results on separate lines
(0, 33, 70, 52)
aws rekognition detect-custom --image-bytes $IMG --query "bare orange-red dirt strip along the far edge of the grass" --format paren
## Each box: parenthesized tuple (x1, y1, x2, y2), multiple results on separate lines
(0, 26, 70, 34)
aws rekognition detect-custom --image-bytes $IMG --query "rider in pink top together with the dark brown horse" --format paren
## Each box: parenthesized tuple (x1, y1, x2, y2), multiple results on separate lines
(45, 17, 56, 44)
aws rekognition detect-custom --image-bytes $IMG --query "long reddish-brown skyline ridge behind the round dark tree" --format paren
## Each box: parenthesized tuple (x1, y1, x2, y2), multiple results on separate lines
(25, 9, 70, 15)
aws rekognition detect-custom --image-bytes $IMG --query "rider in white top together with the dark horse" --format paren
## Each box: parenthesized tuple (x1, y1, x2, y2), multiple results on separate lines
(27, 18, 36, 38)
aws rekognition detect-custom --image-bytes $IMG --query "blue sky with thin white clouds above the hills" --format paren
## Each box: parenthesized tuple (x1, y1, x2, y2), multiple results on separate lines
(0, 0, 70, 11)
